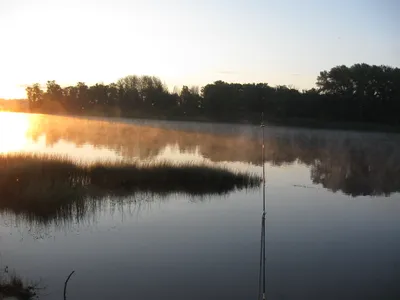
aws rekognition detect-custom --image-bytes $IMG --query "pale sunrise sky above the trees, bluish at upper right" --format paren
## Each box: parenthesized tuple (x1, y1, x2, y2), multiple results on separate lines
(0, 0, 400, 98)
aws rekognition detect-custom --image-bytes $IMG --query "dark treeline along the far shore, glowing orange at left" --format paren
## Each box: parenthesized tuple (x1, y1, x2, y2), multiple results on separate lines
(26, 64, 400, 125)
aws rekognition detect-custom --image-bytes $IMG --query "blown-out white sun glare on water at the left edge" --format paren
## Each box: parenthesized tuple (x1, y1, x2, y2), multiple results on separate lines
(0, 112, 31, 154)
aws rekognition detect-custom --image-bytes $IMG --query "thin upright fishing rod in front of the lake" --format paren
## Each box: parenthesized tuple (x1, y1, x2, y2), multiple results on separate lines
(258, 113, 266, 300)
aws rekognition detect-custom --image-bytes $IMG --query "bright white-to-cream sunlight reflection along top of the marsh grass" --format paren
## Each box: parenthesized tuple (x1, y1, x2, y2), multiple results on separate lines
(0, 112, 258, 172)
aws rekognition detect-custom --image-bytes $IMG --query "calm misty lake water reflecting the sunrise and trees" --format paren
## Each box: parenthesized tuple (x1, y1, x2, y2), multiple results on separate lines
(0, 113, 400, 300)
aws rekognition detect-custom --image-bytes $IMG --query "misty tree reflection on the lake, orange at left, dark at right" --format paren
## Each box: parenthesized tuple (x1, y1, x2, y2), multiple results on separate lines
(28, 116, 400, 196)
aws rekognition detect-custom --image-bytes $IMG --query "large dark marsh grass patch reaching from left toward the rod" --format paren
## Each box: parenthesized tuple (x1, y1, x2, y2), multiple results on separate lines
(0, 154, 260, 218)
